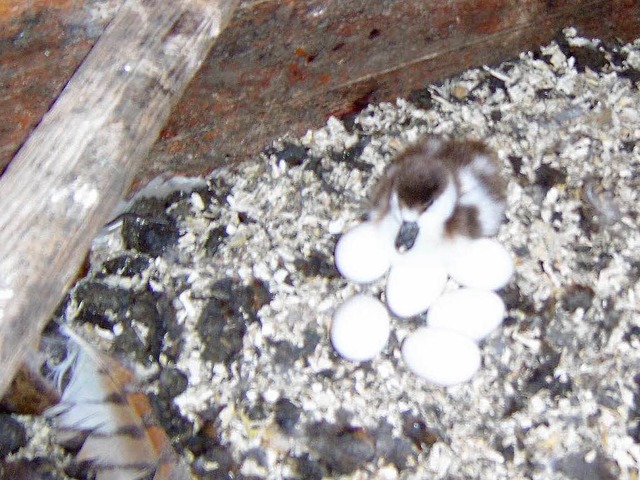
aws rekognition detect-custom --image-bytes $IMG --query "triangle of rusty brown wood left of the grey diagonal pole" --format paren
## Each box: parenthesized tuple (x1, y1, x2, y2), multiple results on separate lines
(0, 0, 124, 171)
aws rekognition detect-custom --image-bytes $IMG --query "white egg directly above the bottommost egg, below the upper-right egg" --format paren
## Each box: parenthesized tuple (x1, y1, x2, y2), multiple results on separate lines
(427, 288, 505, 342)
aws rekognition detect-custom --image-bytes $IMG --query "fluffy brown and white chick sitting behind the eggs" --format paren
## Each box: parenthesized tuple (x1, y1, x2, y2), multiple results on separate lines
(371, 136, 506, 252)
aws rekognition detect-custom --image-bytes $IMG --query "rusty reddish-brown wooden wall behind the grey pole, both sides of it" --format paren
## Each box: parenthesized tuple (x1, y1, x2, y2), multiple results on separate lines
(0, 0, 640, 191)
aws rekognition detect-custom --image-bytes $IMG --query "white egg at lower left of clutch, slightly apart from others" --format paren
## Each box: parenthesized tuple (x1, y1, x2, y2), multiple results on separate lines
(331, 294, 390, 362)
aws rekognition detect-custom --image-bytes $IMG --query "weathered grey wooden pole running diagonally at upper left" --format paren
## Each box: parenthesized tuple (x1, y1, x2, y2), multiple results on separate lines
(0, 0, 236, 394)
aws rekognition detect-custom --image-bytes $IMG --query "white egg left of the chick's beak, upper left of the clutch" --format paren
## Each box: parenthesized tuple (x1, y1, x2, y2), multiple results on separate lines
(335, 222, 393, 283)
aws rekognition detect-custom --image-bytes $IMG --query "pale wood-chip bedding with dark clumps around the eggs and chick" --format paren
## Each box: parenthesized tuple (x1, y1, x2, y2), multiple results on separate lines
(0, 29, 640, 480)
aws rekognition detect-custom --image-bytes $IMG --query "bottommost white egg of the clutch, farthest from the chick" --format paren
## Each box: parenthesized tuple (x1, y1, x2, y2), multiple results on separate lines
(402, 327, 480, 387)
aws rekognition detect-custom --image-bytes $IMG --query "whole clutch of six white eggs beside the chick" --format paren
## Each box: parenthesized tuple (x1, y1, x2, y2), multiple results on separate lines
(331, 220, 513, 386)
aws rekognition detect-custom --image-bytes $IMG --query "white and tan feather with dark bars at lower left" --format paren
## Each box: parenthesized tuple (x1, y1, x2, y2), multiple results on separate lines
(46, 327, 191, 480)
